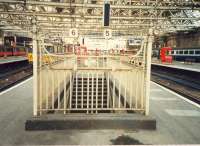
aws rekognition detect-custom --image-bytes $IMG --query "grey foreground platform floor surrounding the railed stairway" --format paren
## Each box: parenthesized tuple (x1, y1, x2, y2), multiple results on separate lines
(0, 79, 200, 145)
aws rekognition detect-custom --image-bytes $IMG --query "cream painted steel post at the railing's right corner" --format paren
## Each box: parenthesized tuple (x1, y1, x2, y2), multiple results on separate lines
(145, 28, 153, 115)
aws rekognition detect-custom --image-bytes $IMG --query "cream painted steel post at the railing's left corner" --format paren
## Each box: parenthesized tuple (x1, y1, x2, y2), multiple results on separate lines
(32, 19, 38, 116)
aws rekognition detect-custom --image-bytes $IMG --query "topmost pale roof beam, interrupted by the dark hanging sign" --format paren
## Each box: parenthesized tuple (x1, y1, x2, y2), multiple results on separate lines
(0, 0, 200, 10)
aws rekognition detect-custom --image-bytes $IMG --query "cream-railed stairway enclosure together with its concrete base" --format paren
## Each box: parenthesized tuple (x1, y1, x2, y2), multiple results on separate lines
(26, 34, 156, 129)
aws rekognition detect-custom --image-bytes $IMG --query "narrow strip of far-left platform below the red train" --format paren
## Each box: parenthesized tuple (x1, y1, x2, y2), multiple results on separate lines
(0, 56, 27, 65)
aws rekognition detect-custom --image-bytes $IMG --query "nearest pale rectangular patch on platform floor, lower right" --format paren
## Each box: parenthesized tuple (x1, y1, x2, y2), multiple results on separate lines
(165, 109, 200, 117)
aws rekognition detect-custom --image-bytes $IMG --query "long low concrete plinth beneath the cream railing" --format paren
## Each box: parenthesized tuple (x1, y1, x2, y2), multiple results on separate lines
(25, 111, 156, 131)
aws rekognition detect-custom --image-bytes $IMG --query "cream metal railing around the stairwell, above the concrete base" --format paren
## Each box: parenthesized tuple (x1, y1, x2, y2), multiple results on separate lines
(34, 30, 151, 115)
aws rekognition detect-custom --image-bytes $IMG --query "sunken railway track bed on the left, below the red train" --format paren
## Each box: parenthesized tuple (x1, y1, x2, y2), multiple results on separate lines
(0, 62, 33, 92)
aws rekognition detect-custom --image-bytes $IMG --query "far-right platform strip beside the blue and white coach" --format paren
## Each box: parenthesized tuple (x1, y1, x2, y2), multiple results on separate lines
(152, 58, 200, 72)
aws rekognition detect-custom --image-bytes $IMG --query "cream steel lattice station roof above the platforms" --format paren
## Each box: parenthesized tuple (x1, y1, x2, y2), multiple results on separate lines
(0, 0, 200, 37)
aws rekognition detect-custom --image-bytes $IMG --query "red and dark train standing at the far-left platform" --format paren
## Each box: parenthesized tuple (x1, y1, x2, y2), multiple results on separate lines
(0, 36, 32, 57)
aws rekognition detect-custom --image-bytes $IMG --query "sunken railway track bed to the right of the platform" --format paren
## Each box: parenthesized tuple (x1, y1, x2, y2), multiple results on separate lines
(151, 65, 200, 104)
